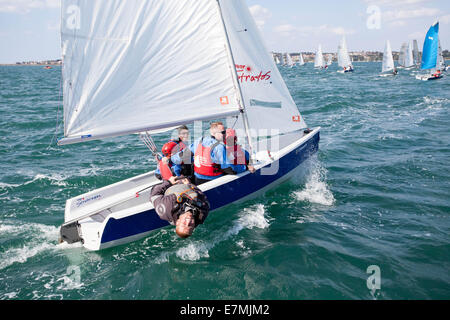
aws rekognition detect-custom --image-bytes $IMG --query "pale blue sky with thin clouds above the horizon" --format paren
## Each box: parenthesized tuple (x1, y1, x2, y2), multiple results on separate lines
(0, 0, 450, 63)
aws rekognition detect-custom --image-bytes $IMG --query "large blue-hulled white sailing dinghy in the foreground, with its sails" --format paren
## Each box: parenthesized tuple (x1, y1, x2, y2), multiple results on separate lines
(58, 0, 320, 250)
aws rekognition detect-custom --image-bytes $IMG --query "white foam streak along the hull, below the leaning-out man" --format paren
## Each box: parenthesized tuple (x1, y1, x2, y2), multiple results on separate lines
(176, 204, 270, 261)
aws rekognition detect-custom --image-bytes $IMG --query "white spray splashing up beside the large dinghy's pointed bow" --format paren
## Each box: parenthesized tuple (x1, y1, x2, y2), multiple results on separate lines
(294, 162, 335, 206)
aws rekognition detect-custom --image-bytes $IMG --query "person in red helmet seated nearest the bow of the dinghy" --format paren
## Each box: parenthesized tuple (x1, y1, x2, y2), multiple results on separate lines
(225, 128, 255, 173)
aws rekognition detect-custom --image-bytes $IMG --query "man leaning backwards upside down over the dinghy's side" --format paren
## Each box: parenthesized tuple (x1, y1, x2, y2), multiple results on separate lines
(150, 176, 210, 238)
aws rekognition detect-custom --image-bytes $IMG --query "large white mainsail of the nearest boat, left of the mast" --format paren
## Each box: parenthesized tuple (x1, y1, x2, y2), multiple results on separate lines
(59, 0, 240, 144)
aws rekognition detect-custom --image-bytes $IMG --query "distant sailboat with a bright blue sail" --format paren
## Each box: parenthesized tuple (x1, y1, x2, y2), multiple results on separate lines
(416, 22, 443, 81)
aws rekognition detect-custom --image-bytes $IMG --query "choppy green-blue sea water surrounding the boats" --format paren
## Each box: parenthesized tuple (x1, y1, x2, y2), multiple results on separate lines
(0, 63, 450, 300)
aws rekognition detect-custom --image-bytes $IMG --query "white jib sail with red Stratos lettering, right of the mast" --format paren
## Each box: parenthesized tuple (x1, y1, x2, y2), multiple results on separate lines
(220, 0, 306, 151)
